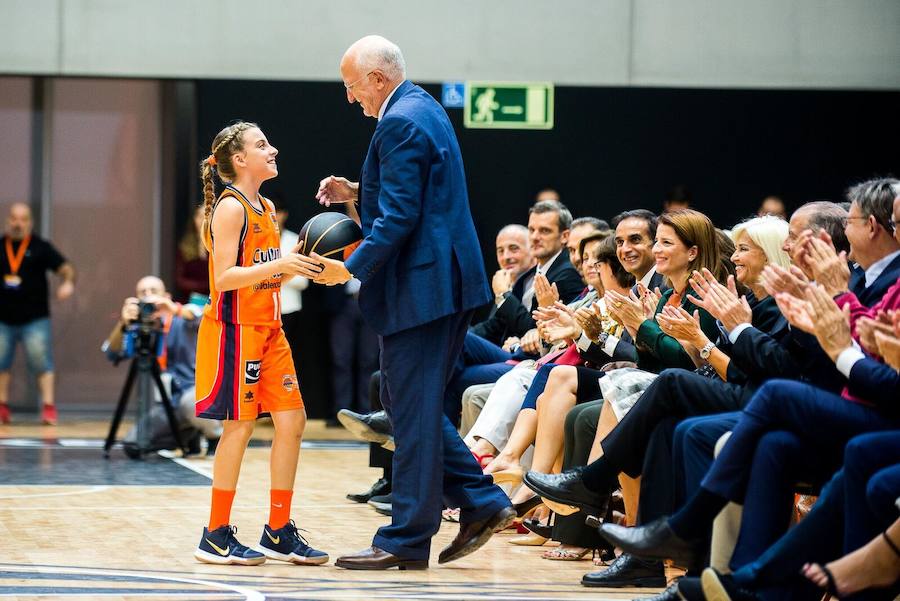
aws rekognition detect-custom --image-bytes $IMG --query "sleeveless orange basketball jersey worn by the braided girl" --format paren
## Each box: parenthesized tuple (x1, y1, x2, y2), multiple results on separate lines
(204, 186, 281, 328)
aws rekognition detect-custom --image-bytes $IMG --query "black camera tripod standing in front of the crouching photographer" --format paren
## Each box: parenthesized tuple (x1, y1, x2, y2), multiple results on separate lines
(103, 328, 188, 459)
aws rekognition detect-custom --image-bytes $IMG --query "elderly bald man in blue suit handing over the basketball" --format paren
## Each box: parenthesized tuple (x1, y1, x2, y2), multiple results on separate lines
(298, 36, 515, 570)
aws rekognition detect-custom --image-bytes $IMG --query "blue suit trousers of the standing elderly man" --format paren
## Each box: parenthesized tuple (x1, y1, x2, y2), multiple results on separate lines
(373, 311, 510, 559)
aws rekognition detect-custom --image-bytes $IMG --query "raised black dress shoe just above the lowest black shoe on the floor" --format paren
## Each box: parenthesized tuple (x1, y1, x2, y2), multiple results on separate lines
(598, 518, 705, 566)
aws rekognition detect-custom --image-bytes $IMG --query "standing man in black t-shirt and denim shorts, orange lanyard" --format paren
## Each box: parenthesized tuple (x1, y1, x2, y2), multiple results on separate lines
(0, 203, 75, 425)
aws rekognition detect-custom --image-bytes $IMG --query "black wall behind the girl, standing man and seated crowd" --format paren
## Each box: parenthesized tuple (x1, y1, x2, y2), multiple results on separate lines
(197, 81, 900, 415)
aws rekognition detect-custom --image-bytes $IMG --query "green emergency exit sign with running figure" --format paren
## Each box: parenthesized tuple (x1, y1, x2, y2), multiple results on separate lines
(463, 81, 553, 129)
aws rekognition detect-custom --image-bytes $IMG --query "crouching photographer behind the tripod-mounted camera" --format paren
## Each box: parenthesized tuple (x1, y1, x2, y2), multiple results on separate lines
(101, 275, 222, 458)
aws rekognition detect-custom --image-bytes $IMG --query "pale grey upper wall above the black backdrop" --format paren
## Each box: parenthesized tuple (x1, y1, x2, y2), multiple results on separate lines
(0, 0, 900, 89)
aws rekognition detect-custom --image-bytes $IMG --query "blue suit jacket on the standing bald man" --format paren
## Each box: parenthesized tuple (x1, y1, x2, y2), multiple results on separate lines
(345, 81, 492, 335)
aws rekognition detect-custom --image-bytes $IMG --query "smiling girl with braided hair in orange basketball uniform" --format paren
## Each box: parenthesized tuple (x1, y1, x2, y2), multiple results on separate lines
(194, 122, 328, 565)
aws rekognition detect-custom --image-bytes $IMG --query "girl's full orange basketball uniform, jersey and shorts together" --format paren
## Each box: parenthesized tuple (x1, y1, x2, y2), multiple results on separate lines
(196, 186, 303, 420)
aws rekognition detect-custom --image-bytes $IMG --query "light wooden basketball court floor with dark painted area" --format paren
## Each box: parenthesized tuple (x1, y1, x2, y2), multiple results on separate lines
(0, 422, 672, 600)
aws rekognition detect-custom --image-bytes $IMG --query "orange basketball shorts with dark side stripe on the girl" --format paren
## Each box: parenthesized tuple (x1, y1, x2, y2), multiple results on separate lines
(196, 315, 303, 420)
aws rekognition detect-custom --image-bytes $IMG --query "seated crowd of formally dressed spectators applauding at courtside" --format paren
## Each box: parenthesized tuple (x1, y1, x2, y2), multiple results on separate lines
(342, 179, 900, 600)
